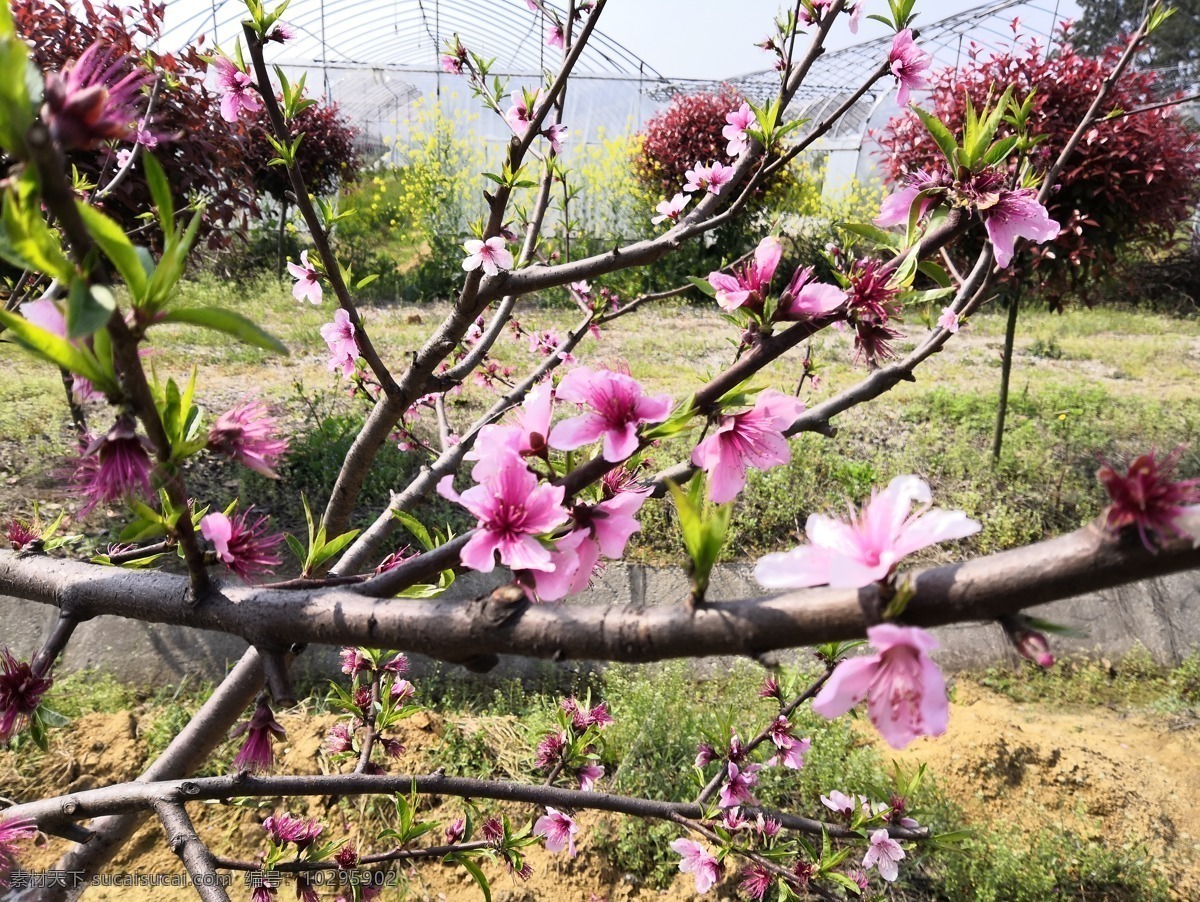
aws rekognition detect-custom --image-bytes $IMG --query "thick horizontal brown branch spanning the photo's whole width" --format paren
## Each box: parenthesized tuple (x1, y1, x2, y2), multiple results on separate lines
(0, 524, 1200, 662)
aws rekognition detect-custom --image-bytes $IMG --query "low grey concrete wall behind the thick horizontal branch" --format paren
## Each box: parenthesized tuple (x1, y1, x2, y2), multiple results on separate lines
(0, 564, 1200, 682)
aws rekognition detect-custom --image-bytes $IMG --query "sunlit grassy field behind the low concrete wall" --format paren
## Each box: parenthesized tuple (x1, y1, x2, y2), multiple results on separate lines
(0, 277, 1200, 563)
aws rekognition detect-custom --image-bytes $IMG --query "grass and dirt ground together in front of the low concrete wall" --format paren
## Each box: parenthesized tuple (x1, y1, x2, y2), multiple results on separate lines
(0, 651, 1200, 902)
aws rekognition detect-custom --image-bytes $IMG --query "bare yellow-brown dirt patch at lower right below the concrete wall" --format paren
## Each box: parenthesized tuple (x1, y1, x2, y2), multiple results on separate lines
(892, 682, 1200, 900)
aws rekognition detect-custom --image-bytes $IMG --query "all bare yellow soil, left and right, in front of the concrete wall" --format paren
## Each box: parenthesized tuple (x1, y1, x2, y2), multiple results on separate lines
(9, 681, 1200, 902)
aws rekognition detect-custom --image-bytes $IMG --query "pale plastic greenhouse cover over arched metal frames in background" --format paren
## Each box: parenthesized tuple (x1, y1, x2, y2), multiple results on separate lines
(152, 0, 1069, 170)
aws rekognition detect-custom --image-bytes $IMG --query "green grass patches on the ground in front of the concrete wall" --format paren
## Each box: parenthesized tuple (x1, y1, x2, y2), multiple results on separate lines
(4, 650, 1200, 902)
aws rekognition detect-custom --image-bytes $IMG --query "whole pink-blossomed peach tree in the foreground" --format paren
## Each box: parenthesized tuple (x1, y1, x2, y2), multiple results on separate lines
(0, 0, 1200, 902)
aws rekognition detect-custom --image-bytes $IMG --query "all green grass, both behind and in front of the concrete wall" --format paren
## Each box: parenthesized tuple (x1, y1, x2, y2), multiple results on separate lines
(0, 278, 1200, 900)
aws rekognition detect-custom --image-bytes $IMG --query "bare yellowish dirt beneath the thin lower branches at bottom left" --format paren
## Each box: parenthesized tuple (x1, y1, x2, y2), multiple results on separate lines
(9, 711, 695, 902)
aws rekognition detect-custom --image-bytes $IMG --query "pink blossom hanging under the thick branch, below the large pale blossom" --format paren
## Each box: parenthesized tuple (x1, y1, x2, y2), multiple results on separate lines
(812, 624, 949, 748)
